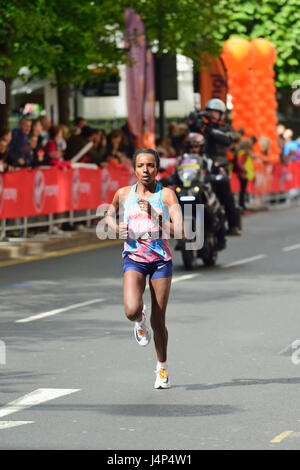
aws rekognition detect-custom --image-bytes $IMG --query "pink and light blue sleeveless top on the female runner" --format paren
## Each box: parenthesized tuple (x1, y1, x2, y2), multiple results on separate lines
(122, 182, 172, 263)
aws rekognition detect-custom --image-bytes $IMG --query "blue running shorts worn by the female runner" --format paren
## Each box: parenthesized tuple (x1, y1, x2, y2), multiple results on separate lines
(123, 255, 173, 279)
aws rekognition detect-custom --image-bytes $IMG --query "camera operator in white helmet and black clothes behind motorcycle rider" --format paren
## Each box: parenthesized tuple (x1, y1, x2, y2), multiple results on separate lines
(189, 98, 242, 235)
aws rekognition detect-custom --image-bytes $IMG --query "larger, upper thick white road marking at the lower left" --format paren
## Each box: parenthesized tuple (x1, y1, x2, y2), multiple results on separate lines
(0, 388, 80, 418)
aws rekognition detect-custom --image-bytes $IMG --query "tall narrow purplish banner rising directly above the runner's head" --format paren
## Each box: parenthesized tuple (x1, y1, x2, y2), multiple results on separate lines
(125, 8, 146, 148)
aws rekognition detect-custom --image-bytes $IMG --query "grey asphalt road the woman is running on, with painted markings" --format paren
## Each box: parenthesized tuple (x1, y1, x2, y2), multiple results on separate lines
(0, 207, 300, 450)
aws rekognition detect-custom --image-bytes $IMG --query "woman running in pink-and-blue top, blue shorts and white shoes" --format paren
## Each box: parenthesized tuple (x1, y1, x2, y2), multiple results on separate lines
(106, 149, 184, 389)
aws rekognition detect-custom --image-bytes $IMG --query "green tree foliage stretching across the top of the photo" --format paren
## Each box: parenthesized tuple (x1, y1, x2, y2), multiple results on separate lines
(0, 0, 300, 91)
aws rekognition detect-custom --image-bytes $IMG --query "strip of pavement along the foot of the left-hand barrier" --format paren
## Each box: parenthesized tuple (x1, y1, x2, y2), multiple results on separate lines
(0, 227, 123, 261)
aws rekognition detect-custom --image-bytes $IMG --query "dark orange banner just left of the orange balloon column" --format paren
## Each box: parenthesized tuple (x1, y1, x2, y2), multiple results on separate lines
(199, 54, 227, 111)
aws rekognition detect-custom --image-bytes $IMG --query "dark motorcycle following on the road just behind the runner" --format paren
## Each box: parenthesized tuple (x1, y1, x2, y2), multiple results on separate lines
(161, 153, 226, 270)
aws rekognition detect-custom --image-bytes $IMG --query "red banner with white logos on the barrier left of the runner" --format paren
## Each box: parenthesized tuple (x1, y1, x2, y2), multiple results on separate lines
(0, 165, 129, 219)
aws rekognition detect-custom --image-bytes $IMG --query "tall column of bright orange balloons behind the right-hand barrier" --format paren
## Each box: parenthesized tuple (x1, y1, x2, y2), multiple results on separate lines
(222, 38, 279, 173)
